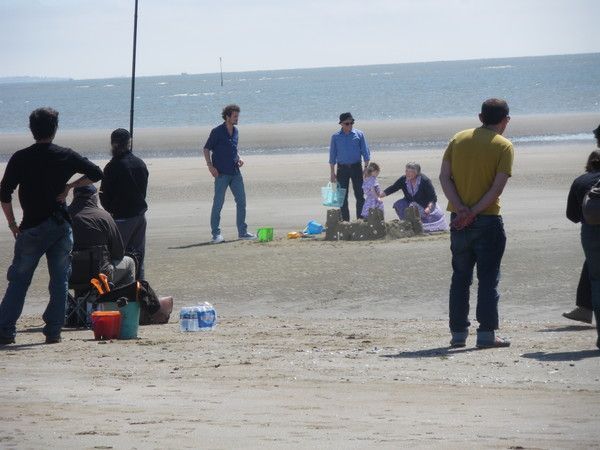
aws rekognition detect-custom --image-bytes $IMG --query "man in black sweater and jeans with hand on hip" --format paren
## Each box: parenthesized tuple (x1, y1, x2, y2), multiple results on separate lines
(0, 108, 102, 345)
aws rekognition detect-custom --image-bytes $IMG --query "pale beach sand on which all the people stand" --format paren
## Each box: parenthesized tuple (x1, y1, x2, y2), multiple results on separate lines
(0, 124, 600, 449)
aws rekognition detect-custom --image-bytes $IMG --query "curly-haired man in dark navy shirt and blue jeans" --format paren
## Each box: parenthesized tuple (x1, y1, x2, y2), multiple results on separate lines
(204, 105, 256, 244)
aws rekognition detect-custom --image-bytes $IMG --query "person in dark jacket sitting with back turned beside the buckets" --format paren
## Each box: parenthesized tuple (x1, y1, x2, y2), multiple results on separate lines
(69, 185, 135, 287)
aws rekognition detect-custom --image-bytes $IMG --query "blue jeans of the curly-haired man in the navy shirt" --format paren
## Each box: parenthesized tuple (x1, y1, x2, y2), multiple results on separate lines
(210, 172, 248, 237)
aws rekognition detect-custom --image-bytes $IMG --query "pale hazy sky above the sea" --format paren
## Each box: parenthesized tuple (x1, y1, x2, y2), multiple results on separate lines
(0, 0, 600, 78)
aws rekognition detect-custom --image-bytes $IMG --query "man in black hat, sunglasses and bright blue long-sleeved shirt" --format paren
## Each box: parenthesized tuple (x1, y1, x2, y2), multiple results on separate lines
(329, 112, 370, 221)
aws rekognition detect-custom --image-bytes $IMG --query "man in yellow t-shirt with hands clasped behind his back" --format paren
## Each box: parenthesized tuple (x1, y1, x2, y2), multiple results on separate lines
(440, 98, 514, 348)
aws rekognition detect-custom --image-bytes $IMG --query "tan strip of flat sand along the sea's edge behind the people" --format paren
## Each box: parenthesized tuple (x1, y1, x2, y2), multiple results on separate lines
(0, 113, 600, 160)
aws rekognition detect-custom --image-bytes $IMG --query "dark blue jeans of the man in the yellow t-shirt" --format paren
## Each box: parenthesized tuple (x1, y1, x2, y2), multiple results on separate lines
(450, 214, 506, 333)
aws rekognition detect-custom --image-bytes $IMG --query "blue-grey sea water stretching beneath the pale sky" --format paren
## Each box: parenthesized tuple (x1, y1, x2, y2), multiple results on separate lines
(0, 53, 600, 155)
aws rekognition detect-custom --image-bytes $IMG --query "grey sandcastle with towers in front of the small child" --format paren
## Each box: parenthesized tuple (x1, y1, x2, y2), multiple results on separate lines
(325, 207, 423, 241)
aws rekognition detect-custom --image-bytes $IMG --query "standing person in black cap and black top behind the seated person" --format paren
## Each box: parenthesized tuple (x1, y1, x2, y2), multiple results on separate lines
(100, 128, 148, 279)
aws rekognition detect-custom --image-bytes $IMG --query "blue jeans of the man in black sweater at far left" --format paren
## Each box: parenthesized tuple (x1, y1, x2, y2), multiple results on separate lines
(0, 218, 73, 338)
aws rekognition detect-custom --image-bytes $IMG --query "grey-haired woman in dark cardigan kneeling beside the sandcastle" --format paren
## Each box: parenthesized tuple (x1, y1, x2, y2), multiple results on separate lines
(380, 162, 448, 232)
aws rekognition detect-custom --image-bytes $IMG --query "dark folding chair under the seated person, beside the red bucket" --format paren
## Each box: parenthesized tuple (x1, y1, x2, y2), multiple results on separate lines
(65, 245, 106, 328)
